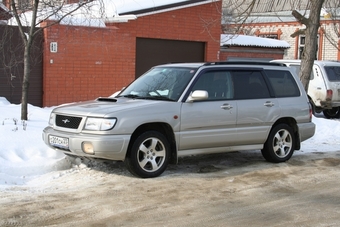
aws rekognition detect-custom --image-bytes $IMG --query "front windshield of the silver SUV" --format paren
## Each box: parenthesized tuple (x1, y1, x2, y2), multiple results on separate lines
(118, 67, 197, 101)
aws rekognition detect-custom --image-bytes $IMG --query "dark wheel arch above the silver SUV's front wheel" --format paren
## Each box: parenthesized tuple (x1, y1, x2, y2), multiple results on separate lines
(126, 122, 177, 164)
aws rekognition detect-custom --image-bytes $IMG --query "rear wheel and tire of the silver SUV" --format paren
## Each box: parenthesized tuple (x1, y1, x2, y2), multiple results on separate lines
(261, 124, 295, 163)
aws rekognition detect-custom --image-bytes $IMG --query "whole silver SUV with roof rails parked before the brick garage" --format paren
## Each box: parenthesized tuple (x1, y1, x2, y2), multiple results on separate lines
(43, 62, 315, 178)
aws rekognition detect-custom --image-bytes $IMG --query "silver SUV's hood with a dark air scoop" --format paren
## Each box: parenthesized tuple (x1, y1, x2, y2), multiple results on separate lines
(53, 97, 173, 117)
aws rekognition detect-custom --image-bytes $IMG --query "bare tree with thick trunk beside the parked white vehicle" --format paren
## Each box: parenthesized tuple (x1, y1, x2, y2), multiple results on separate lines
(223, 0, 325, 91)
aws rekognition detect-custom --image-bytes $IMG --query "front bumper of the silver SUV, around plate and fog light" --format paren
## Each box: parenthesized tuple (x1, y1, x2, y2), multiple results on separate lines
(42, 127, 130, 161)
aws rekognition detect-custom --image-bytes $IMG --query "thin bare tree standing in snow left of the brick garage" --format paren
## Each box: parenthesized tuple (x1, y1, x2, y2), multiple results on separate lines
(7, 0, 99, 120)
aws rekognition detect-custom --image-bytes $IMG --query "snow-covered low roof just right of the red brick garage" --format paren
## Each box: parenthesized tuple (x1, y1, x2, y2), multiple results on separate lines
(220, 34, 290, 49)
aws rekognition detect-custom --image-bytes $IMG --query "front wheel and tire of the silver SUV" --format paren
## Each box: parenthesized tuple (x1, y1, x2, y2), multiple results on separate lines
(124, 131, 170, 178)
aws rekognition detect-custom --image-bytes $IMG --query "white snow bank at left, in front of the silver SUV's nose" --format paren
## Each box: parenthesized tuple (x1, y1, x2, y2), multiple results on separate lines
(0, 97, 71, 185)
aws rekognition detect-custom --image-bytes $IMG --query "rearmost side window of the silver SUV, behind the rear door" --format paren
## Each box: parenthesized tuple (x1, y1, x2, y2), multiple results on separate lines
(266, 70, 300, 98)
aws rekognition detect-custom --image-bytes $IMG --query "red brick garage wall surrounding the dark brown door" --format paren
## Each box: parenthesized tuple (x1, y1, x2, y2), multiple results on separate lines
(43, 2, 221, 106)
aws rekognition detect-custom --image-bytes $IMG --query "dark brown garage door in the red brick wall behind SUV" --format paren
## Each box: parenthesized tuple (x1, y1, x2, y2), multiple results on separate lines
(135, 38, 205, 78)
